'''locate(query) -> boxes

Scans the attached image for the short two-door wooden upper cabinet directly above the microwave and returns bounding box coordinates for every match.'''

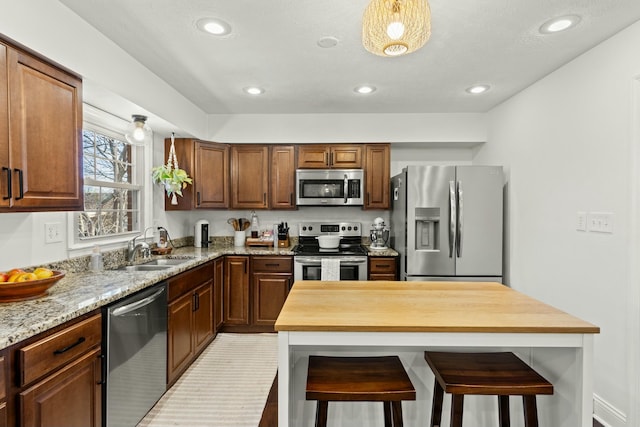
[298,144,363,169]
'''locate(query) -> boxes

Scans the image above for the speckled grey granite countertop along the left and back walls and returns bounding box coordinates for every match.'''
[0,246,398,349]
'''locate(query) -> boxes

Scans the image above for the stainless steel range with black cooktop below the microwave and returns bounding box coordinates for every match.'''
[293,222,367,280]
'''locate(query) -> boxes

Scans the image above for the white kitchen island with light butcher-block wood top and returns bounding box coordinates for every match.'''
[275,281,599,427]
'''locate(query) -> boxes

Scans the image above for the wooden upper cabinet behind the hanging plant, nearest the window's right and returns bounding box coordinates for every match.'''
[164,138,229,210]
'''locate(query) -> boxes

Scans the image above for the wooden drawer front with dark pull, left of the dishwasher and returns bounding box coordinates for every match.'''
[18,314,102,385]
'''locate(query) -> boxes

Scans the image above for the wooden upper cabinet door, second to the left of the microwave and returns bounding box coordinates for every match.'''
[231,145,269,209]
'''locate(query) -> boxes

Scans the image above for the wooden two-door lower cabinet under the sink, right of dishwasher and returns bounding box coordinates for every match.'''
[167,262,214,385]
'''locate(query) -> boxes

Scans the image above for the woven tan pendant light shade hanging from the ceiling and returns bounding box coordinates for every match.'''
[362,0,431,56]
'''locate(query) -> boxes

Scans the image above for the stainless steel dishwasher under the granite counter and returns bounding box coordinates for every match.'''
[103,283,167,427]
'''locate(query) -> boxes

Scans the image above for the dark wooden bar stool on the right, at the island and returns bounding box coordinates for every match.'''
[424,351,553,427]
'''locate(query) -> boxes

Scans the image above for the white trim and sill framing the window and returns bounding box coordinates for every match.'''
[67,103,155,255]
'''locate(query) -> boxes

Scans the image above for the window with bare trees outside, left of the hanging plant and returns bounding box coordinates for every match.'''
[72,104,145,247]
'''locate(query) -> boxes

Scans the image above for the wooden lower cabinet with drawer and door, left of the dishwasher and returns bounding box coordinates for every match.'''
[9,313,102,427]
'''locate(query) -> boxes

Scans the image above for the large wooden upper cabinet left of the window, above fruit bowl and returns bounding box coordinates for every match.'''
[0,40,83,212]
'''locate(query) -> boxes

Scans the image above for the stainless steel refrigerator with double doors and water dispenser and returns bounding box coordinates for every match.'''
[391,166,504,283]
